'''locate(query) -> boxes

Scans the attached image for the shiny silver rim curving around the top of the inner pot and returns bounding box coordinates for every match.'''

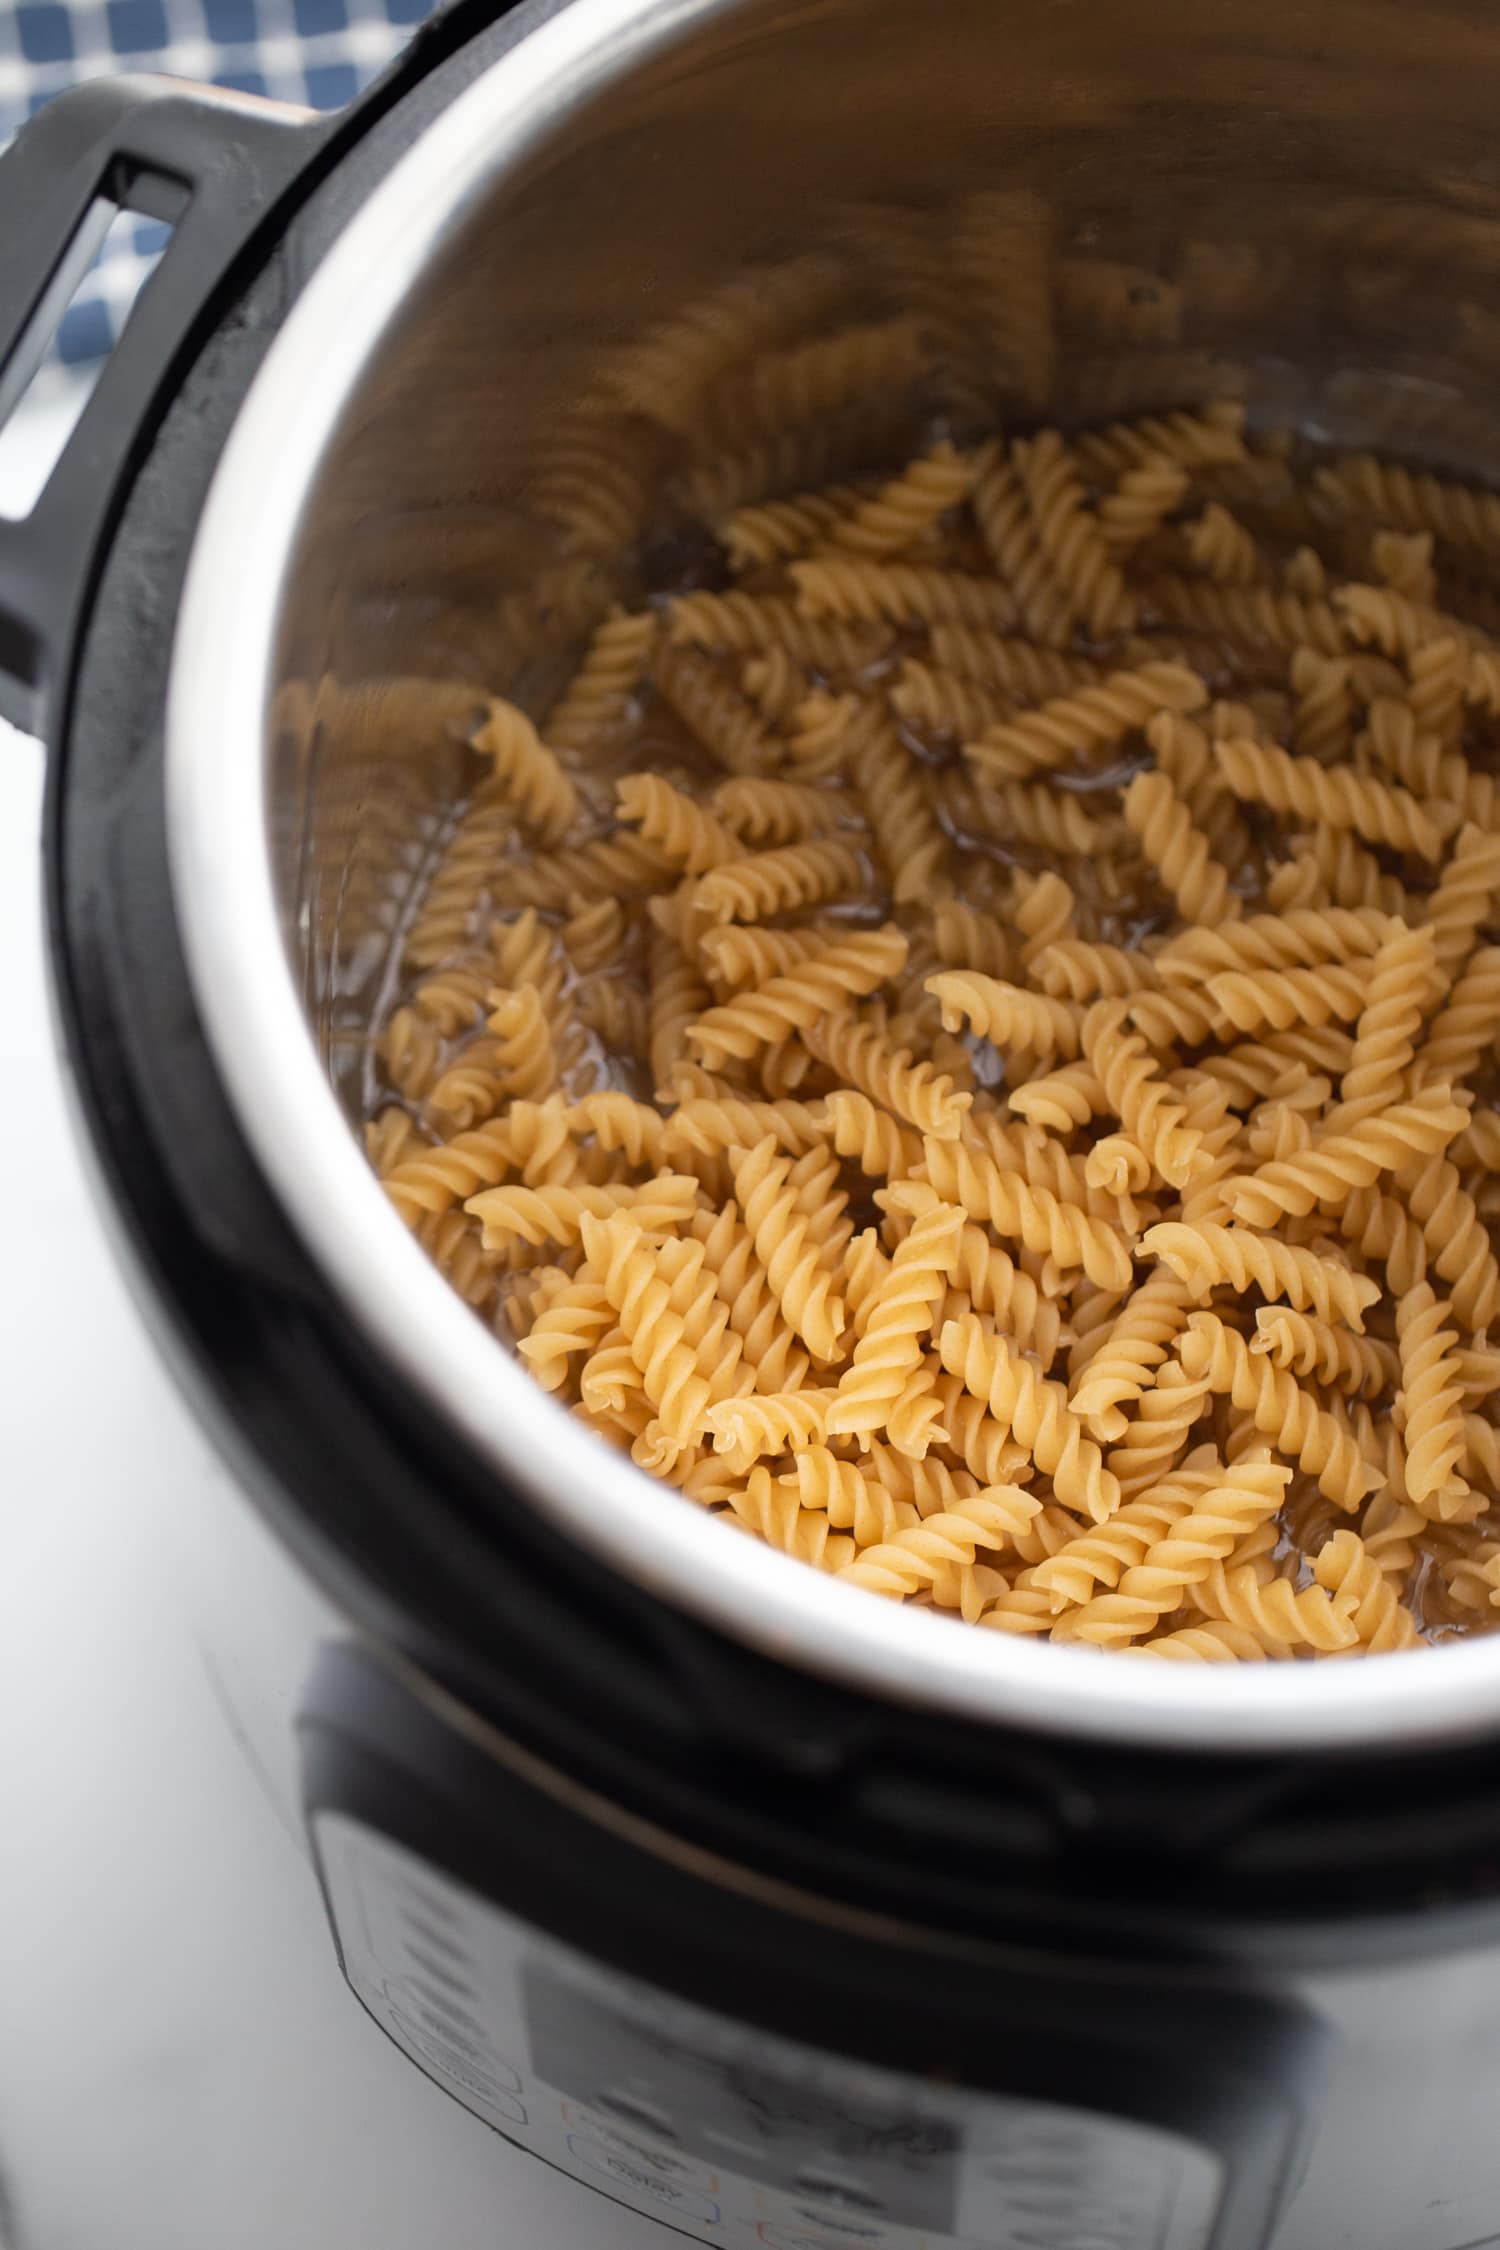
[166,0,1500,1753]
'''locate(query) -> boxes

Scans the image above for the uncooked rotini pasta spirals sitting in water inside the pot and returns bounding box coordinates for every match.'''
[359,391,1500,1663]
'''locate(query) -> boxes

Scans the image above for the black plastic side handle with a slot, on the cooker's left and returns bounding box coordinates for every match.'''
[0,77,328,740]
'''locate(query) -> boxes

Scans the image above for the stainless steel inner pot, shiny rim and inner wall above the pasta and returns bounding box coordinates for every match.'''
[169,0,1500,1748]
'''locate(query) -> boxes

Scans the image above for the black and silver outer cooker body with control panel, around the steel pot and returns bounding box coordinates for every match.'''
[20,0,1500,2250]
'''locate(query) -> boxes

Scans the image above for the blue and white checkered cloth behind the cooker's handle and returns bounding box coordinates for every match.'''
[0,0,434,367]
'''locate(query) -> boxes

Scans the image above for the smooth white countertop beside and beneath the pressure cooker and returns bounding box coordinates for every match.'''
[0,387,659,2250]
